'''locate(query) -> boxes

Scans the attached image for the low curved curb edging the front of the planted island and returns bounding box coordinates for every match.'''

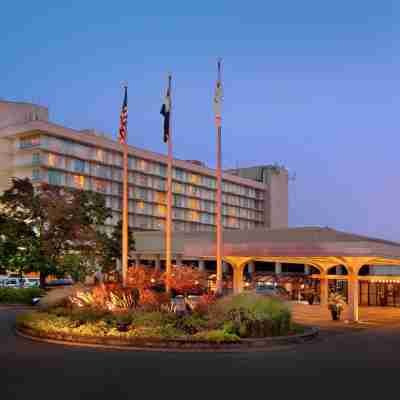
[15,326,319,352]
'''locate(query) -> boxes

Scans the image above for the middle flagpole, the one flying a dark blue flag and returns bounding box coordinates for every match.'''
[165,74,172,293]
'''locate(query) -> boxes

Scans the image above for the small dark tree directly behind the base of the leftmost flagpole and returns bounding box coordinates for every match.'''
[102,220,135,272]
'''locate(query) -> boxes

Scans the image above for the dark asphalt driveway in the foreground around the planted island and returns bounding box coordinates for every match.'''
[0,309,400,400]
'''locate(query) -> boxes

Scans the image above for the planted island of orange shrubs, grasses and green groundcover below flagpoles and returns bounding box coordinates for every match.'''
[17,267,312,345]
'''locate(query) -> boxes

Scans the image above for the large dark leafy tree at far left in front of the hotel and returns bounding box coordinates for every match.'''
[0,178,110,286]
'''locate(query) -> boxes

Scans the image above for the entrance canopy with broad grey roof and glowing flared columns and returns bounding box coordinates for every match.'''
[135,227,400,321]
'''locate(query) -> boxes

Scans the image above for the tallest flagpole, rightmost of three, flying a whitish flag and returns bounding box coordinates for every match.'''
[215,60,222,294]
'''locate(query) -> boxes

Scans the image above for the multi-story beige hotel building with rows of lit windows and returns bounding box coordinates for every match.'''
[0,101,288,232]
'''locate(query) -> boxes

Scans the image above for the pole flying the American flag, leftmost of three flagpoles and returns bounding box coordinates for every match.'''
[122,85,128,287]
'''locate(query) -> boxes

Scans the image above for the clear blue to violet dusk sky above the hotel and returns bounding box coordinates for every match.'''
[0,0,400,241]
